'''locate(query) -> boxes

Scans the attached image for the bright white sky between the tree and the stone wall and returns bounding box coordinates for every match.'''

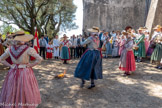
[0,0,83,37]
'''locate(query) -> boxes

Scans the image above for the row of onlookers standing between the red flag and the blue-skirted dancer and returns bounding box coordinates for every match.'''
[39,34,86,64]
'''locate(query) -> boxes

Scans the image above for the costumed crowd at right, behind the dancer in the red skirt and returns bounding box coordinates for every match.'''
[100,25,162,69]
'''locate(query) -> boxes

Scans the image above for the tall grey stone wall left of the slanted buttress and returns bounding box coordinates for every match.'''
[83,0,146,31]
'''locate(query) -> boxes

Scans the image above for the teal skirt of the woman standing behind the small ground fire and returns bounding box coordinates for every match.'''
[60,46,70,60]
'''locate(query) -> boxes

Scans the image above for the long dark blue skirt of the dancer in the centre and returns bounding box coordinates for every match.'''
[74,50,103,80]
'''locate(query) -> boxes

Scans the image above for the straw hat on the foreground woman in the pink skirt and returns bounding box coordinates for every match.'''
[9,31,34,42]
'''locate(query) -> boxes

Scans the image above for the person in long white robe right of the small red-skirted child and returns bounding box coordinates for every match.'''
[53,35,60,59]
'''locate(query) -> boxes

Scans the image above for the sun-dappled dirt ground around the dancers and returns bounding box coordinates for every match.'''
[0,58,162,108]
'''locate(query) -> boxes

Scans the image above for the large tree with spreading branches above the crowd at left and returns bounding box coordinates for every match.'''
[0,0,77,35]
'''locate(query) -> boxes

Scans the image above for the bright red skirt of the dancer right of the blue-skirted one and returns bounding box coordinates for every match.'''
[119,51,136,72]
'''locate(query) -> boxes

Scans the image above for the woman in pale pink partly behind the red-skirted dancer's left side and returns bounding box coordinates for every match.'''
[119,30,128,56]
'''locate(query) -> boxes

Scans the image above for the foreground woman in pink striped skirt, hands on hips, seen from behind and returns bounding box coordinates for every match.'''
[0,31,42,108]
